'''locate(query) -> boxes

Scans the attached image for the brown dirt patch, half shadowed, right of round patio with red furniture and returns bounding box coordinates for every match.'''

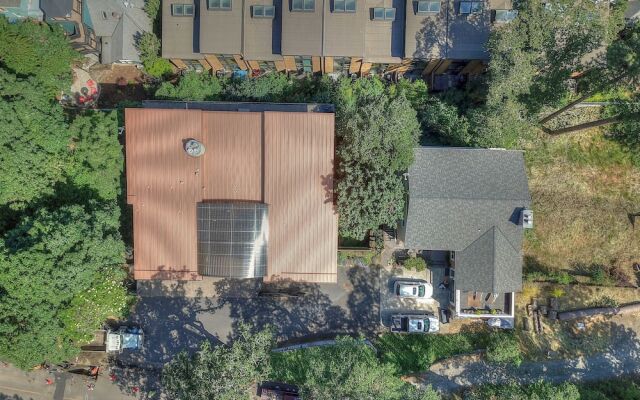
[91,64,148,108]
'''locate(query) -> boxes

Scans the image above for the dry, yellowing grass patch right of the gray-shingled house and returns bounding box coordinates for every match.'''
[524,131,640,283]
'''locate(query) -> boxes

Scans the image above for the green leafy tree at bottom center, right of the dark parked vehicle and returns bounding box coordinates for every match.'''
[272,337,410,400]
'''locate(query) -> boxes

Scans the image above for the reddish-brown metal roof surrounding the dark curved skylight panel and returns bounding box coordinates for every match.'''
[125,108,337,282]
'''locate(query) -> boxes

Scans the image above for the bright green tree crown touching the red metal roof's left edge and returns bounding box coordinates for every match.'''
[66,111,124,200]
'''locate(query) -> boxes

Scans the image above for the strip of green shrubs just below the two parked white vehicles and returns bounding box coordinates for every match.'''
[375,332,488,374]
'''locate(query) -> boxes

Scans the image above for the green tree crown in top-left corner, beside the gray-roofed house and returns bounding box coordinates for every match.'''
[0,17,79,94]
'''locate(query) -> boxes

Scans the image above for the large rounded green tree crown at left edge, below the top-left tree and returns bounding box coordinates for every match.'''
[0,68,70,209]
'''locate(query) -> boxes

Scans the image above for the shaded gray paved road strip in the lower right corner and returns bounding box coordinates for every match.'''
[413,316,640,393]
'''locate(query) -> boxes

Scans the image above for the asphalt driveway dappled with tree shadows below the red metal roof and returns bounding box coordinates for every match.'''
[108,267,380,396]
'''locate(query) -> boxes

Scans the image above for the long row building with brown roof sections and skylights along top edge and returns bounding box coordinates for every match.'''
[162,0,515,75]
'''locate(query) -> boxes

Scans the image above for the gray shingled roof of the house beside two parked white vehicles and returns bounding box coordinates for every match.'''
[404,147,531,292]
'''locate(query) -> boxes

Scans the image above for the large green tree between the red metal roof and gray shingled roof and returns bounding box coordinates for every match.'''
[334,79,420,238]
